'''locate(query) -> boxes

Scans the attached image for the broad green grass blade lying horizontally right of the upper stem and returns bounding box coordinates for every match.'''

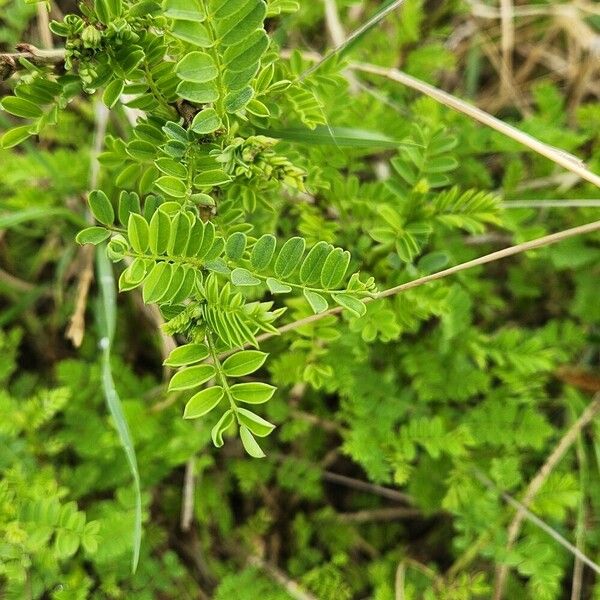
[259,125,416,148]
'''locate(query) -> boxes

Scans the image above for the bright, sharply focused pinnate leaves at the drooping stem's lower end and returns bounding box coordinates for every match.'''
[78,188,374,457]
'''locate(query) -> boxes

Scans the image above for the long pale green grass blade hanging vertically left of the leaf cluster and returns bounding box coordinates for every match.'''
[96,246,142,572]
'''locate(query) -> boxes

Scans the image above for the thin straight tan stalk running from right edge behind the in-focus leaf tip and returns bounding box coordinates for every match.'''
[256,221,600,342]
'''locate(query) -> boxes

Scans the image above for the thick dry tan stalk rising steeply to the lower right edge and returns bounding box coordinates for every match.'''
[493,393,600,600]
